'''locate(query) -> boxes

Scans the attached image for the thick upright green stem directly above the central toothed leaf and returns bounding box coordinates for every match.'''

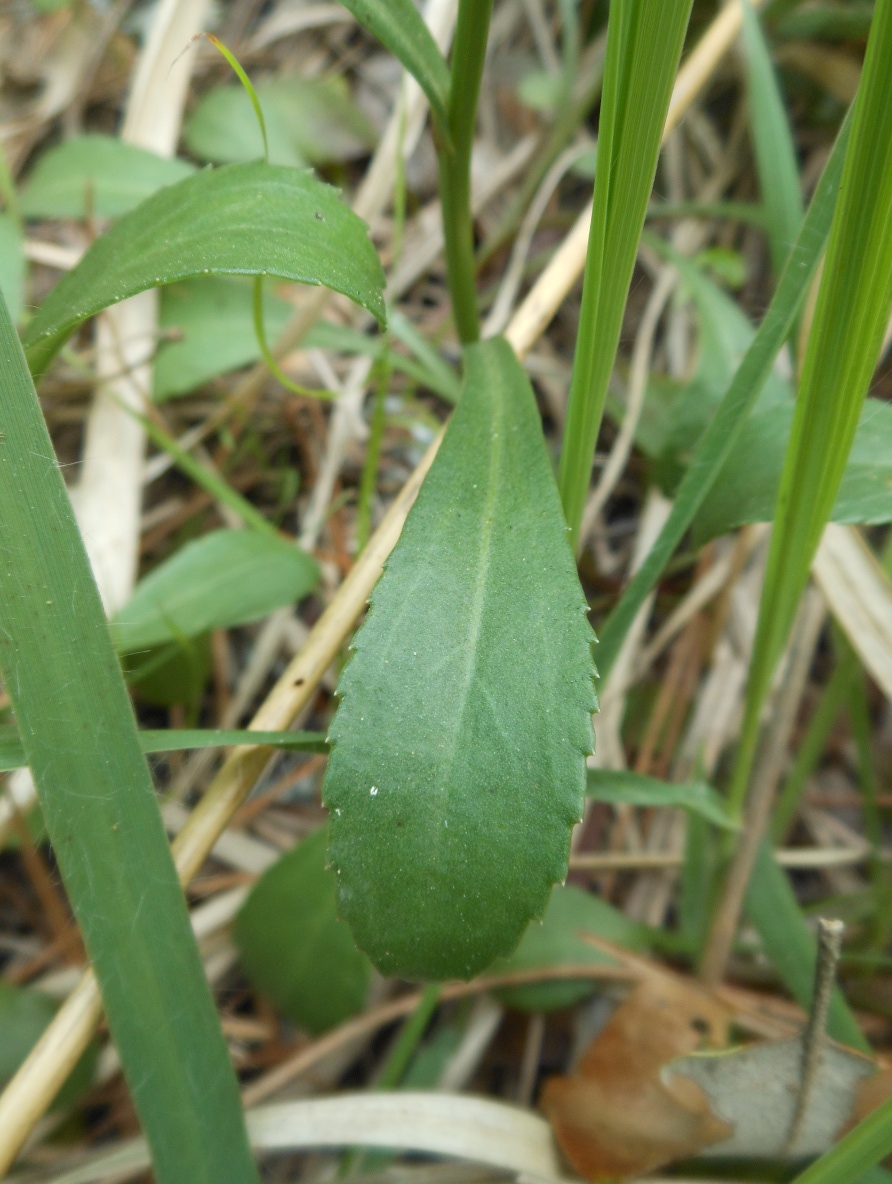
[437,0,493,345]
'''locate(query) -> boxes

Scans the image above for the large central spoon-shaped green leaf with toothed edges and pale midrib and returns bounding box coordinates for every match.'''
[325,339,596,979]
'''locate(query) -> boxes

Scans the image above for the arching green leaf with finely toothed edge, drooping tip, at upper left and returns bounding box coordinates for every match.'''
[25,162,386,373]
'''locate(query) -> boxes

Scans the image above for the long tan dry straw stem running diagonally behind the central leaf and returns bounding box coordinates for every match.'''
[0,0,764,1175]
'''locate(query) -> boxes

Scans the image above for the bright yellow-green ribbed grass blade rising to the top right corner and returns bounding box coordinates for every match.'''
[702,0,892,982]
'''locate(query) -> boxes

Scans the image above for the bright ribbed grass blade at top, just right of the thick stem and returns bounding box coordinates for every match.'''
[558,0,691,546]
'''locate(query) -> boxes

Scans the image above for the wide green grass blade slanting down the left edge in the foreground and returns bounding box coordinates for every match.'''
[0,291,257,1184]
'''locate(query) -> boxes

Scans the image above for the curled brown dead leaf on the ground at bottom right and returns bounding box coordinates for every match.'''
[541,974,732,1180]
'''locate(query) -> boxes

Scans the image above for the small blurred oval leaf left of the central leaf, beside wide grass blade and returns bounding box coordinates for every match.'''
[111,530,319,654]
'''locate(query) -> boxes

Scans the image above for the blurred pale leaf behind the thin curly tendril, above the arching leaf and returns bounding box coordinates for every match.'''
[182,76,376,168]
